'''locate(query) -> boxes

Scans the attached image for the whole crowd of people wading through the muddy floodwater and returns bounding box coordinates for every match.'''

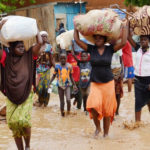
[0,15,150,150]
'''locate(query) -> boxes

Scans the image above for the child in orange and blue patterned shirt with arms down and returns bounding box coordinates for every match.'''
[50,50,77,117]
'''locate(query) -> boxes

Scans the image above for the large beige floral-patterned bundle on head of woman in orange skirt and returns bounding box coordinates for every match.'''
[74,9,122,43]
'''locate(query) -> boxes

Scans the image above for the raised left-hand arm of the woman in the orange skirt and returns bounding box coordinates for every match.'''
[74,29,88,51]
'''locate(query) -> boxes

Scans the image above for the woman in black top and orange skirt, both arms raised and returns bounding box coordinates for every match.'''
[74,19,128,137]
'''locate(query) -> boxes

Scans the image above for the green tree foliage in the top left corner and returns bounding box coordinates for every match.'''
[0,0,36,14]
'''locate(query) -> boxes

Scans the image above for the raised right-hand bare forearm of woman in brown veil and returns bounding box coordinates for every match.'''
[32,32,43,56]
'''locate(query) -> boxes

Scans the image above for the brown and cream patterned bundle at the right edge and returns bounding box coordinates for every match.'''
[129,6,150,35]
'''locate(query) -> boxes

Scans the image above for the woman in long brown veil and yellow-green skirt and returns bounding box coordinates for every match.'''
[0,20,42,150]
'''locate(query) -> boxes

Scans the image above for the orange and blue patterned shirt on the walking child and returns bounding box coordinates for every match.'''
[54,63,72,88]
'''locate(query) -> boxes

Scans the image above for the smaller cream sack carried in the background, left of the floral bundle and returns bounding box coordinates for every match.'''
[56,30,82,50]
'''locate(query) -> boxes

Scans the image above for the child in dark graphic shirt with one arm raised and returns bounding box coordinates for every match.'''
[72,45,92,112]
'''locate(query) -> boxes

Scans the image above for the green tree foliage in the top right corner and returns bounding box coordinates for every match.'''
[125,0,150,7]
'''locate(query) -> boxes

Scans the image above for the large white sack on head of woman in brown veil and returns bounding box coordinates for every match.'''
[0,16,38,42]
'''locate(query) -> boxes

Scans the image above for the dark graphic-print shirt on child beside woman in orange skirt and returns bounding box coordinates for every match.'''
[78,61,92,88]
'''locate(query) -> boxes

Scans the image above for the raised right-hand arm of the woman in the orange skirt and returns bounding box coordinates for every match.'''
[114,20,129,51]
